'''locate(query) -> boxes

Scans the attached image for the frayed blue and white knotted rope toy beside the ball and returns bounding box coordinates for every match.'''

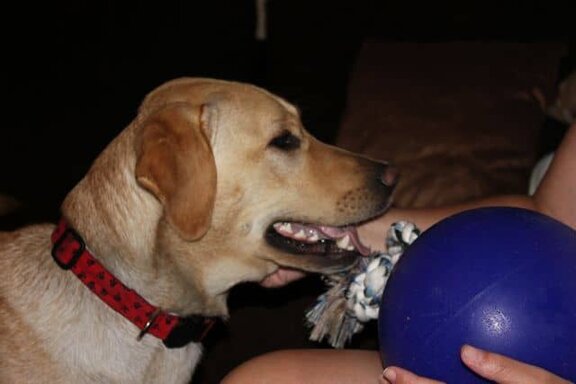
[306,221,420,348]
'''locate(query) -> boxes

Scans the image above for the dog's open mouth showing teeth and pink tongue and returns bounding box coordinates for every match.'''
[265,221,370,259]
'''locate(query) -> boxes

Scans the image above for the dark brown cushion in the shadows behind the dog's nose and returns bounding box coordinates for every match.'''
[336,40,566,207]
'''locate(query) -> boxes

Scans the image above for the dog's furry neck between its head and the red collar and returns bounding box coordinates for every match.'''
[62,127,227,316]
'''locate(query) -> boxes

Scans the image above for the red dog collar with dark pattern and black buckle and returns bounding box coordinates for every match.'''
[52,219,214,348]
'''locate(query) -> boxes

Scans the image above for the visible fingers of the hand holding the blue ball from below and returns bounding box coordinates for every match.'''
[380,345,570,384]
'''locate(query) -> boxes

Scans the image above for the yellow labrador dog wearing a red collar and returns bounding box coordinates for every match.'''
[0,78,395,384]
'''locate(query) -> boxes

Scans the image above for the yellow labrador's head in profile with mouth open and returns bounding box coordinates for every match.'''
[65,79,395,316]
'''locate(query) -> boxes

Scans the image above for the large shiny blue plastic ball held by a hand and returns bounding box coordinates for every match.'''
[378,207,576,383]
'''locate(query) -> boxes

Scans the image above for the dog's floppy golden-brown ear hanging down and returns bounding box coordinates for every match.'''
[136,103,216,240]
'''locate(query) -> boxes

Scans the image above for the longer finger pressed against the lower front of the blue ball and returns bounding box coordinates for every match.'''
[460,345,569,384]
